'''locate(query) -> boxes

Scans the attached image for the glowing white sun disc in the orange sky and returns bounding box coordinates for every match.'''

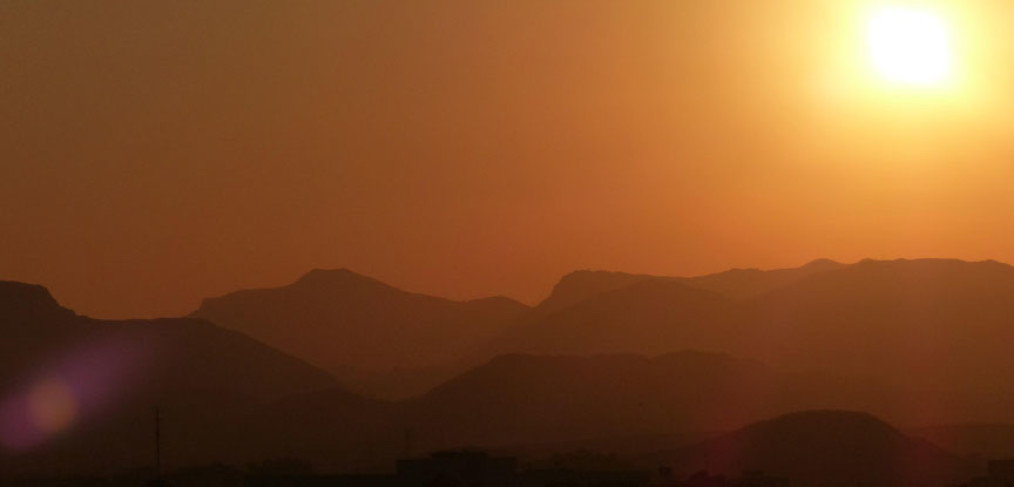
[866,6,953,86]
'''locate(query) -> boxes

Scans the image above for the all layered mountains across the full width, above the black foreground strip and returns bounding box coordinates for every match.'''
[0,256,1014,476]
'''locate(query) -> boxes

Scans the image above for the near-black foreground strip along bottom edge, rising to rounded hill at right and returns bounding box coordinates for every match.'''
[0,411,977,487]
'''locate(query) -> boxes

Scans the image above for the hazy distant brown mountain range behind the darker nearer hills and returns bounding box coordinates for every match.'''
[186,259,1014,422]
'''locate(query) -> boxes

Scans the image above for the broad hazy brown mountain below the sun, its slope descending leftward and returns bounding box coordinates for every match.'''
[491,260,1014,423]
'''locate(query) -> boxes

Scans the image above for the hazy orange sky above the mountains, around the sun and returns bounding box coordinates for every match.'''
[0,0,1014,318]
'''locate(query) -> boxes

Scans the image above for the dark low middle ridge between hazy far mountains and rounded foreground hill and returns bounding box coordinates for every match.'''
[156,351,928,470]
